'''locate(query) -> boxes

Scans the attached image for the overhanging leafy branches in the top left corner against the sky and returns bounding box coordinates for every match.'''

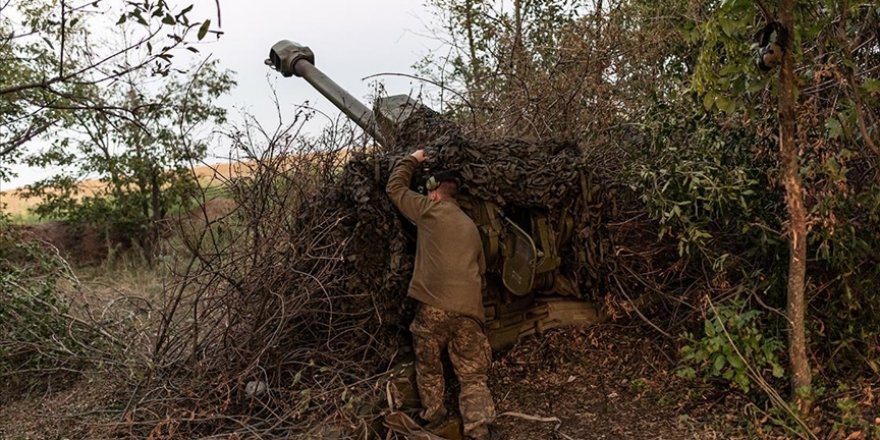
[0,0,219,178]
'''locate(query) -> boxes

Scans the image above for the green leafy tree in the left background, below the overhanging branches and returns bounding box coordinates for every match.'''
[26,61,234,257]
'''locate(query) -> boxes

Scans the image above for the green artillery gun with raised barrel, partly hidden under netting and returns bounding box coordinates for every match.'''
[266,40,605,350]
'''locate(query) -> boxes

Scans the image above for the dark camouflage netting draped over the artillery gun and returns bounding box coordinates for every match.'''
[314,138,607,308]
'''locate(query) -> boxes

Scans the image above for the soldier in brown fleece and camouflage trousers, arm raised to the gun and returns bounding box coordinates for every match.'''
[386,150,495,440]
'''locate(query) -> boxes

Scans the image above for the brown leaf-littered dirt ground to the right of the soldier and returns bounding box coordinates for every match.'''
[490,324,751,440]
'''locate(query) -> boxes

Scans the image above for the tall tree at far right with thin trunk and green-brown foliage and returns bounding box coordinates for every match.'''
[693,0,880,413]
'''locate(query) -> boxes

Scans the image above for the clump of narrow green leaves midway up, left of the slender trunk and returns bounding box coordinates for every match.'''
[628,97,782,262]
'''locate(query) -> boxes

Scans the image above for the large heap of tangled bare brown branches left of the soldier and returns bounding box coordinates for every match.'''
[120,115,411,438]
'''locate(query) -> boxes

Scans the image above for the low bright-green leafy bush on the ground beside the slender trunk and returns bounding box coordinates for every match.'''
[678,303,785,392]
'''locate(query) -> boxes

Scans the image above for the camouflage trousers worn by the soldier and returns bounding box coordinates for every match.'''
[409,304,495,438]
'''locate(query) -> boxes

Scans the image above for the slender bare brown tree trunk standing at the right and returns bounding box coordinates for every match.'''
[779,0,812,415]
